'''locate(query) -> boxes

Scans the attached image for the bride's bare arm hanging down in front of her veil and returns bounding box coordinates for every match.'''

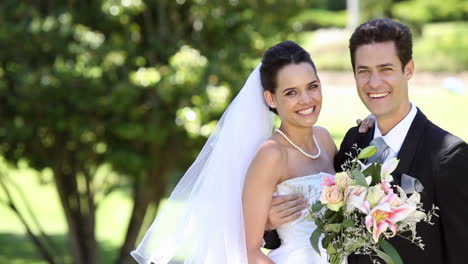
[242,141,287,264]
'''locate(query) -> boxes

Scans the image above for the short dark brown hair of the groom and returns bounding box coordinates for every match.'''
[349,18,413,72]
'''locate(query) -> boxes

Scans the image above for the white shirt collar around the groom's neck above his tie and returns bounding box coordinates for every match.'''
[374,103,417,153]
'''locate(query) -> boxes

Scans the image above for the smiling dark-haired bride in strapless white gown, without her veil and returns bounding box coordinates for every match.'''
[243,41,336,263]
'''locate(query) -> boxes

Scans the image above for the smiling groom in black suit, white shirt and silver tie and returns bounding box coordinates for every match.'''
[265,19,468,264]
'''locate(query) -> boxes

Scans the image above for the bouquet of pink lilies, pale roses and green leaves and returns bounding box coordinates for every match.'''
[310,146,437,264]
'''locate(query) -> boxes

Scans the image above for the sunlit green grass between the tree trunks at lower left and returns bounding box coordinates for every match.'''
[0,166,131,264]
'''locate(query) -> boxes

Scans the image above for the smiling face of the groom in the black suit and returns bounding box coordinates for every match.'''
[354,41,414,120]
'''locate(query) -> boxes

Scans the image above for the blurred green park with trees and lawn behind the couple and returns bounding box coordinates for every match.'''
[0,0,468,264]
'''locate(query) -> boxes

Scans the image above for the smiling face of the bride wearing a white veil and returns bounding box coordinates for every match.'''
[265,62,322,128]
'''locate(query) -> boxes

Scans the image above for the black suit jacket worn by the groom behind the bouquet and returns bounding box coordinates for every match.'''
[265,109,468,264]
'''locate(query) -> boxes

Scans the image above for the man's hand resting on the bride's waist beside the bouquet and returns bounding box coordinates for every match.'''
[265,194,309,231]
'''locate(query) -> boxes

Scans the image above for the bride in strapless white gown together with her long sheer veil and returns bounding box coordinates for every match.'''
[131,41,368,264]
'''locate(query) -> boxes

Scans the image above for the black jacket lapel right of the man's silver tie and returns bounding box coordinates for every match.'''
[392,109,428,185]
